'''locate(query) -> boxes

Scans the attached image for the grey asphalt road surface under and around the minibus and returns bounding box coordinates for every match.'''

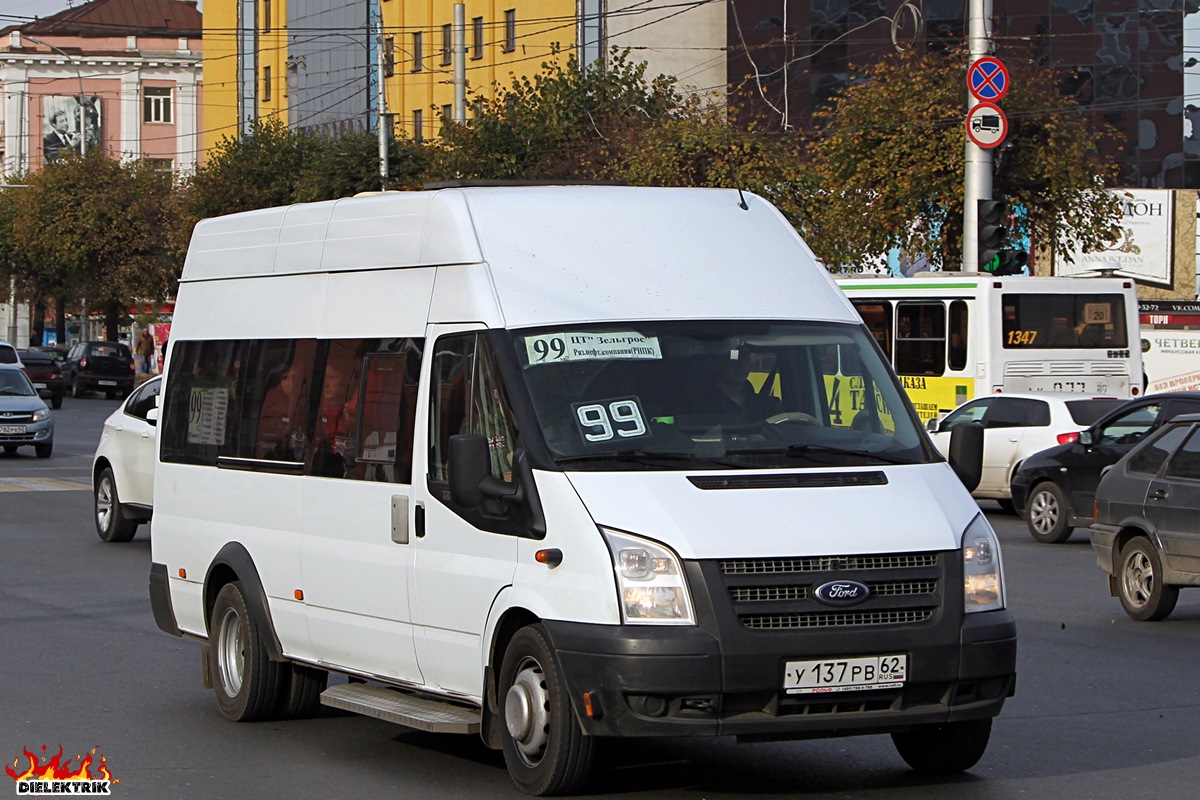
[0,398,1200,800]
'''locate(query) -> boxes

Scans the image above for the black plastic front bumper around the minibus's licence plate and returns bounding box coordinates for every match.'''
[545,556,1016,739]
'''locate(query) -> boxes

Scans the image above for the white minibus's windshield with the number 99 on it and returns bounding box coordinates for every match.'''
[512,320,938,470]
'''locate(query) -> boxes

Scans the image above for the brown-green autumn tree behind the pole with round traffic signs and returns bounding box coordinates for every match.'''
[803,52,1120,269]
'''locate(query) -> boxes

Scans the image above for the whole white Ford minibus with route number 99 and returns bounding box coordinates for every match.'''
[150,186,1016,795]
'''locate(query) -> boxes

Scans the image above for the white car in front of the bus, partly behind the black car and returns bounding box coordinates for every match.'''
[929,392,1121,511]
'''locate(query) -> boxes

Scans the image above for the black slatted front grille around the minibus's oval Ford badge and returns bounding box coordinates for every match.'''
[716,552,948,631]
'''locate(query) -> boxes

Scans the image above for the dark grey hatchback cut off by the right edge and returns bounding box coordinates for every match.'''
[1091,414,1200,620]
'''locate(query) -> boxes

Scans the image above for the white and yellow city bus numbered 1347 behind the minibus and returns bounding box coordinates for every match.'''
[838,272,1145,422]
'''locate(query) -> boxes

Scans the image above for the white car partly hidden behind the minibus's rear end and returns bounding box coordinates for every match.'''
[91,378,162,542]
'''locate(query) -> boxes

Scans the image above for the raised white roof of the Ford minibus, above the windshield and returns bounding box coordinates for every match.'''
[181,186,858,326]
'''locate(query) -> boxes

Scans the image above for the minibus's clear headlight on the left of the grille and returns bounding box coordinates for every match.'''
[600,528,696,625]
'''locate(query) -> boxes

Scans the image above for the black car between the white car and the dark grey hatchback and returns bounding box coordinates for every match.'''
[1012,392,1200,543]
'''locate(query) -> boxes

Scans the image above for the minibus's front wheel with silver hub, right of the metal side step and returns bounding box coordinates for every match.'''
[499,625,595,796]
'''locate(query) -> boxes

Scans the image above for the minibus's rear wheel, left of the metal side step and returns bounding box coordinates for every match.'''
[209,581,287,722]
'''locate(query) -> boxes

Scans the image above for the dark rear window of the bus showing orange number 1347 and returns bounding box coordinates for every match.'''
[1001,293,1129,350]
